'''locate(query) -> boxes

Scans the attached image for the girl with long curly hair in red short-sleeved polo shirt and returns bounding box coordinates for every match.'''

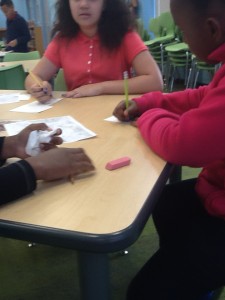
[25,0,163,102]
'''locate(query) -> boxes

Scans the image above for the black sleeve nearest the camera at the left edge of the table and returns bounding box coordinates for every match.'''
[0,160,36,204]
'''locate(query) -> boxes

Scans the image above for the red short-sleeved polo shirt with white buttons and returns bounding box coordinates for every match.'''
[44,31,147,90]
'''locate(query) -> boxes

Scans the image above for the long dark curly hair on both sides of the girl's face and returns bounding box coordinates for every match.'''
[52,0,135,50]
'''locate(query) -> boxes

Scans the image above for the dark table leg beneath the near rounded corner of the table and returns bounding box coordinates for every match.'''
[78,252,110,300]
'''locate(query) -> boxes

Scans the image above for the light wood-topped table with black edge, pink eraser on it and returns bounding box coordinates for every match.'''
[0,91,171,300]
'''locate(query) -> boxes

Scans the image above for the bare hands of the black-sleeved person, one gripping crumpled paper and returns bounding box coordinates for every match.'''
[1,123,95,180]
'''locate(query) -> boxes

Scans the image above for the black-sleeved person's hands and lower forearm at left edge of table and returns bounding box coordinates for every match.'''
[0,123,94,204]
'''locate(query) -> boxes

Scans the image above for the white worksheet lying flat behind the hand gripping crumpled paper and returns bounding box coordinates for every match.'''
[4,116,96,143]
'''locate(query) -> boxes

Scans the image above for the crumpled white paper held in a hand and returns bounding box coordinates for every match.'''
[25,129,57,156]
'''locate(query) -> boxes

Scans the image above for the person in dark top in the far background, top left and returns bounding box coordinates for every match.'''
[0,0,31,52]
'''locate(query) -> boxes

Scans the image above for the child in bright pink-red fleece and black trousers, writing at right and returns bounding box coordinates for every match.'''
[114,0,225,300]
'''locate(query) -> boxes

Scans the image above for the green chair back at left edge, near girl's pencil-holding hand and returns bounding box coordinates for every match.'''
[0,64,26,90]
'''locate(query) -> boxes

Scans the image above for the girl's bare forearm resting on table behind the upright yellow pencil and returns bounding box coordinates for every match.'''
[99,75,163,94]
